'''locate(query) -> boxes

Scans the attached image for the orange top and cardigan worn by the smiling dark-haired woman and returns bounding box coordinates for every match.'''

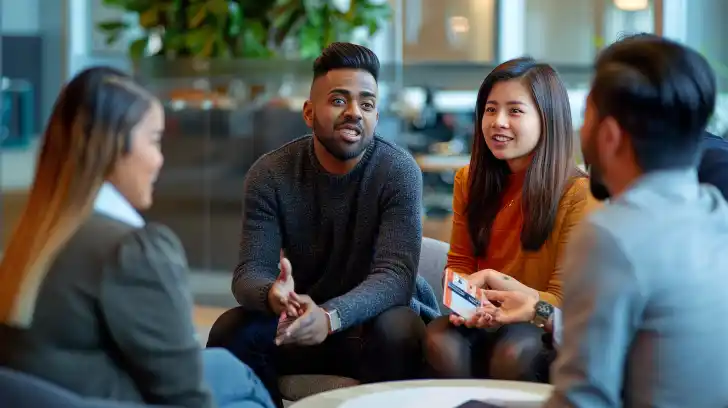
[447,167,599,306]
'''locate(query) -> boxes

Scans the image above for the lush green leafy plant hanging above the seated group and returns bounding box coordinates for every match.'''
[98,0,391,59]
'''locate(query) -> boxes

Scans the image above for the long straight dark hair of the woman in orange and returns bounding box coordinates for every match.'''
[467,58,583,257]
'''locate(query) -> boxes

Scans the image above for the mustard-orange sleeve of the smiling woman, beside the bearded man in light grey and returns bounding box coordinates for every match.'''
[538,178,599,306]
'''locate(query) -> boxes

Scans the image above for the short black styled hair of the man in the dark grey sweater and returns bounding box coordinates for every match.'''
[313,42,379,81]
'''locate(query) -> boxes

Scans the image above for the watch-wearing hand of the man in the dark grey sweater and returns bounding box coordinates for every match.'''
[276,294,329,346]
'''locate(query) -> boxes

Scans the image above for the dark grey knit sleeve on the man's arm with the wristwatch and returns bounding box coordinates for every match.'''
[322,157,422,329]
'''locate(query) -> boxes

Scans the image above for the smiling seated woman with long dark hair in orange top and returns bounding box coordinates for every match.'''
[425,58,596,381]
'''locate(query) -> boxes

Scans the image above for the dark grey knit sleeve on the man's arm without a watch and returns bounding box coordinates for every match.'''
[232,160,282,312]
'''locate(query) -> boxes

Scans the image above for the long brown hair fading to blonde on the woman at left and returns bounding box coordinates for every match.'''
[0,67,152,327]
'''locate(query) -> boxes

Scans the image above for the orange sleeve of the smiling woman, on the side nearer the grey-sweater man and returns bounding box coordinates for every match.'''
[447,167,478,275]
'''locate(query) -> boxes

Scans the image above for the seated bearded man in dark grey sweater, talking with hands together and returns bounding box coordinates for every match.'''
[210,43,424,403]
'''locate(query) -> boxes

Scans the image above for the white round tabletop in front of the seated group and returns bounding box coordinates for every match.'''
[291,380,551,408]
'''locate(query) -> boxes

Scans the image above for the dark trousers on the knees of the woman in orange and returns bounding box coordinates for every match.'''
[425,316,553,382]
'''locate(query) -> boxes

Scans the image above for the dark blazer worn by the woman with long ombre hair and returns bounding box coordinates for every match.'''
[0,214,213,408]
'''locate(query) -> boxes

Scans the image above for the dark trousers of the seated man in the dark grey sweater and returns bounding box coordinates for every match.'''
[208,306,425,406]
